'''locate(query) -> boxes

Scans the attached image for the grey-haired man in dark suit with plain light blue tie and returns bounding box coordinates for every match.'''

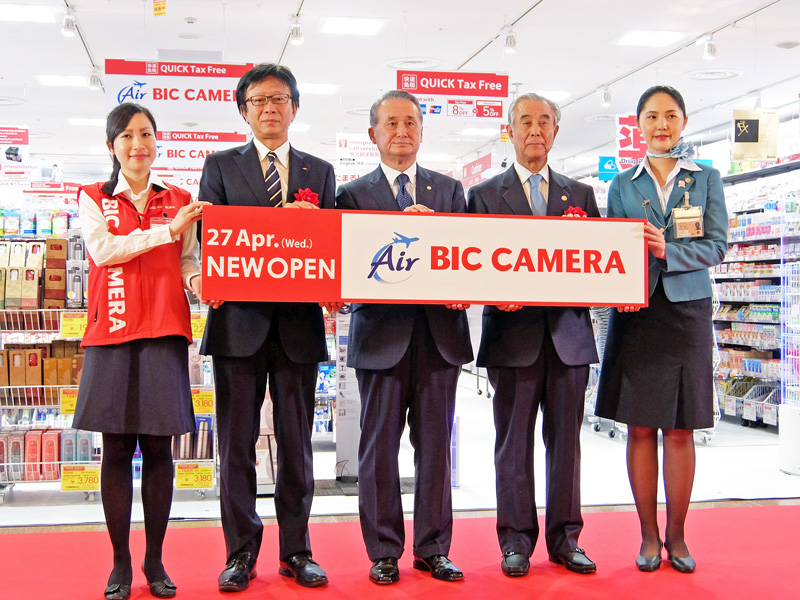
[467,94,600,577]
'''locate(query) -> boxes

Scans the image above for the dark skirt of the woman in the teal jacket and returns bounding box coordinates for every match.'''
[595,281,714,429]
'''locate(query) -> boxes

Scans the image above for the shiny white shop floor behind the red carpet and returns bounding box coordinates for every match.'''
[0,373,800,527]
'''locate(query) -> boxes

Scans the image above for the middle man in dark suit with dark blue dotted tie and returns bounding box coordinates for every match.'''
[336,90,472,584]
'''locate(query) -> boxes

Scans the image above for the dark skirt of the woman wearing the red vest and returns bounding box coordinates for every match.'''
[72,335,195,436]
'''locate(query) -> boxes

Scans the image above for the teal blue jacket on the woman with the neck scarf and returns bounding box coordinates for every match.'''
[608,164,728,302]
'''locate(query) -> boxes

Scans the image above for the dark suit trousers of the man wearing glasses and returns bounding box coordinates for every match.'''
[214,326,317,560]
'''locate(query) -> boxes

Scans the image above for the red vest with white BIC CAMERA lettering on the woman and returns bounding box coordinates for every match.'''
[81,183,192,346]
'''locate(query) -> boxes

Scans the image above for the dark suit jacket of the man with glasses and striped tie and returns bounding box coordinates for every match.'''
[199,142,335,363]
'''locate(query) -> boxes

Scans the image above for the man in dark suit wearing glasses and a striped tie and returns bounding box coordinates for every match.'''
[199,64,338,591]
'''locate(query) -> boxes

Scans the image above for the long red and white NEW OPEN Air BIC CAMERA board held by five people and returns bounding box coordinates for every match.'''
[202,206,647,306]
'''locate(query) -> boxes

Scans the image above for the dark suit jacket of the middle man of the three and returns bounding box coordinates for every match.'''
[336,165,472,369]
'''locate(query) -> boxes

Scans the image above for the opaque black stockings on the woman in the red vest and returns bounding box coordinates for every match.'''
[100,433,173,585]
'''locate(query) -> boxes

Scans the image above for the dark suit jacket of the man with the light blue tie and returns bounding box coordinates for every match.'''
[467,165,600,367]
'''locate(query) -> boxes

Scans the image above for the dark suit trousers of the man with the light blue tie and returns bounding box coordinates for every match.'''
[488,331,589,556]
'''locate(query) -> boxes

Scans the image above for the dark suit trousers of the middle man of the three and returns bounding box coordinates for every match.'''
[356,309,461,561]
